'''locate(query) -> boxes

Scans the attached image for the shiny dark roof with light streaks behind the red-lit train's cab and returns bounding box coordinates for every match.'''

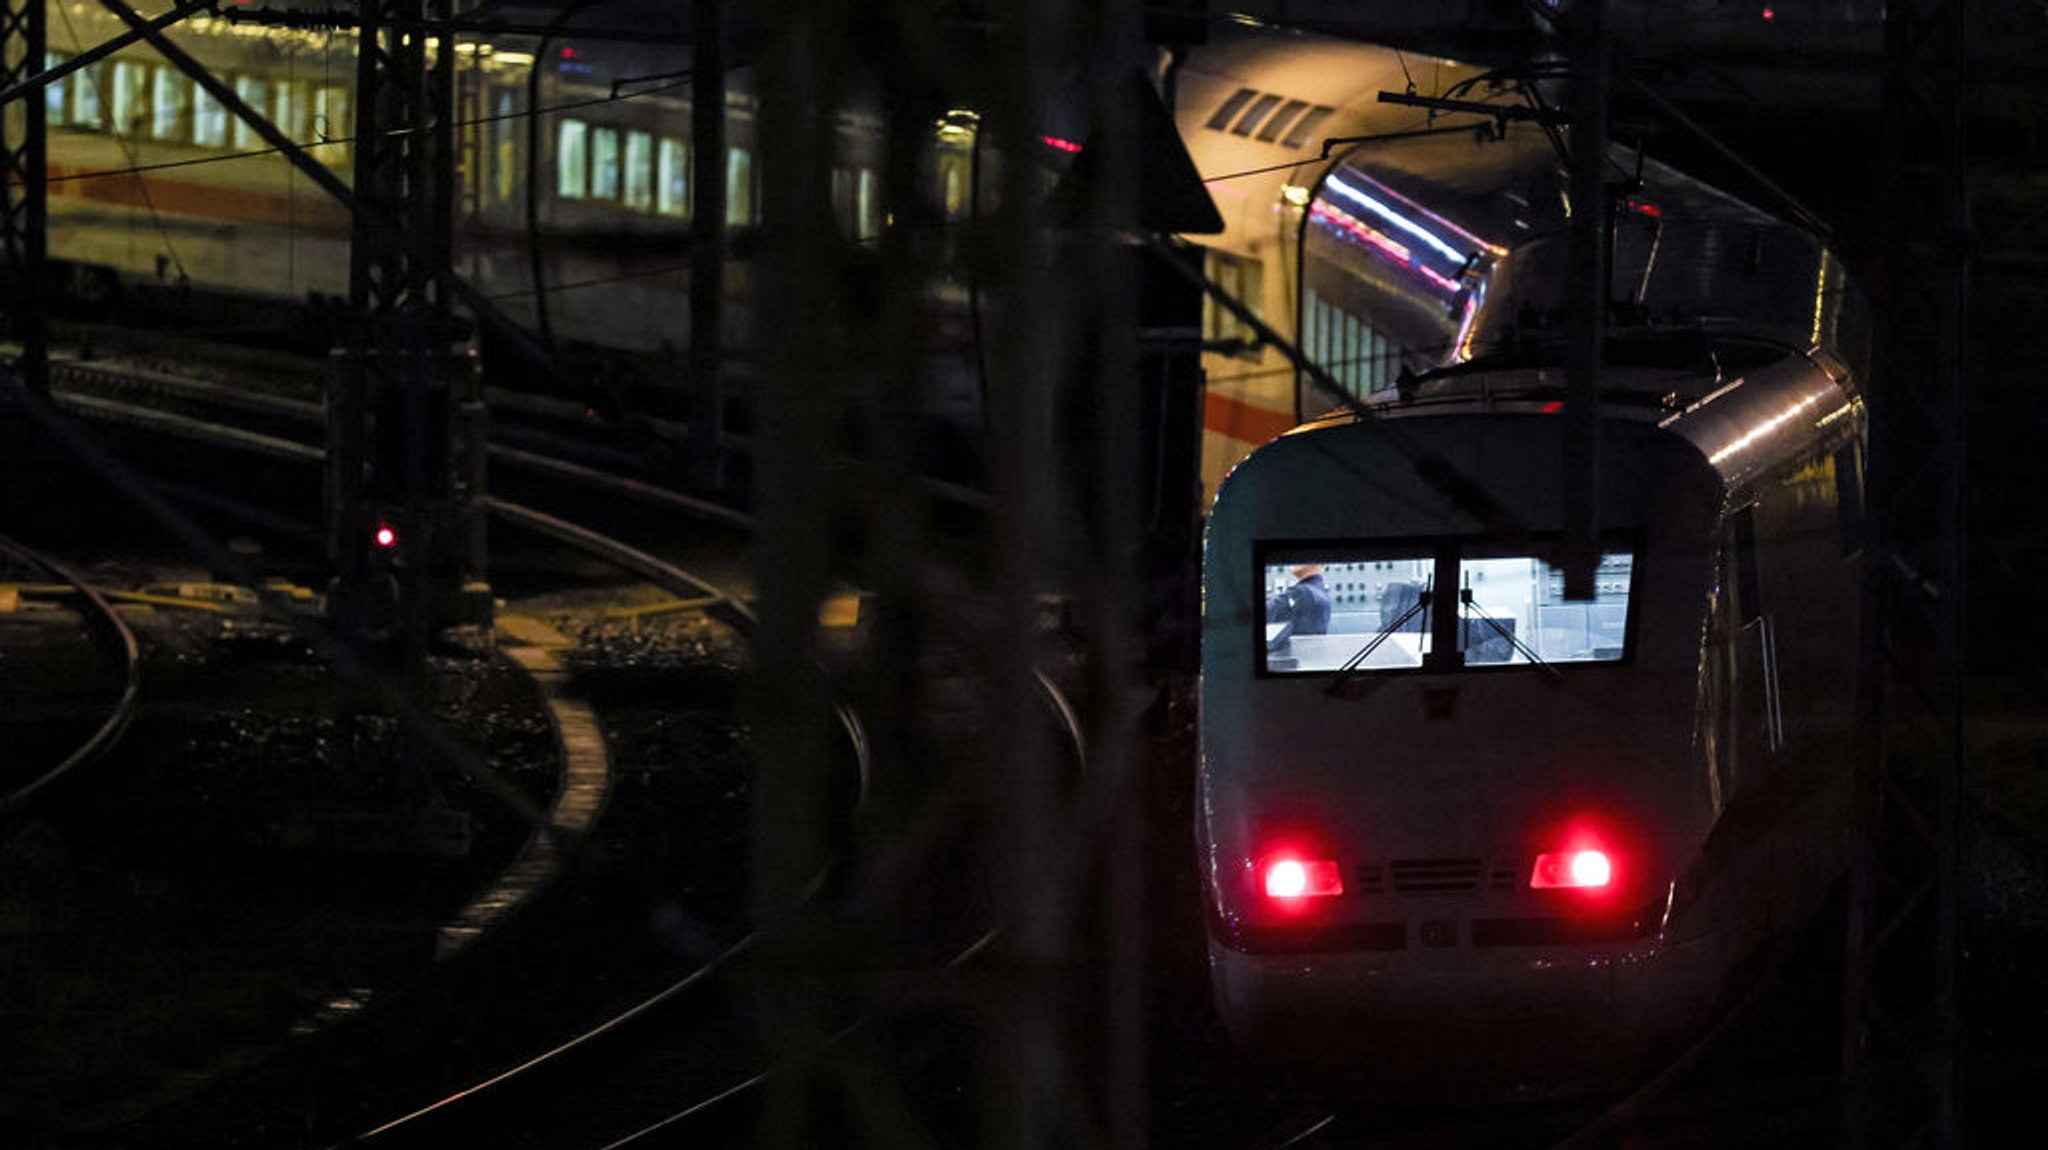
[1303,121,1868,387]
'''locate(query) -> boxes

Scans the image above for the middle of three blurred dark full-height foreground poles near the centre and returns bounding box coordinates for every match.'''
[981,0,1081,1150]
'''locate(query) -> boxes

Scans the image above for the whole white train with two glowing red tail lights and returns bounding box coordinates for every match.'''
[1182,24,1870,1105]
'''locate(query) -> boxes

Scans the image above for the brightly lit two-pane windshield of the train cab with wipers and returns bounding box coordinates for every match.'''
[1260,540,1634,675]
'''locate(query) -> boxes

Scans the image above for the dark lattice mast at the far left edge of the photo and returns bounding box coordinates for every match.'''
[0,0,49,395]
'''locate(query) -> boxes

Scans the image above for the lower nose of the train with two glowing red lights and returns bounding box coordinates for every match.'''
[1210,776,1718,1101]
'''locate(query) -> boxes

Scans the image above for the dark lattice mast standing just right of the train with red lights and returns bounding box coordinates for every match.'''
[1843,0,1972,1150]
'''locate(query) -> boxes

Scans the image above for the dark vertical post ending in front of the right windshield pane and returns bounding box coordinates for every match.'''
[1563,0,1608,600]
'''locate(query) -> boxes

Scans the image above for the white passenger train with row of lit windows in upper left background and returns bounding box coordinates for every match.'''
[28,2,950,341]
